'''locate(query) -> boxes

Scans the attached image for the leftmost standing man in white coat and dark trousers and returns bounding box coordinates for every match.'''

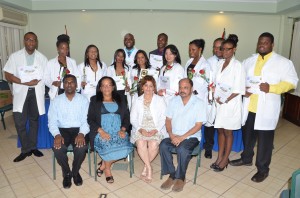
[3,32,48,162]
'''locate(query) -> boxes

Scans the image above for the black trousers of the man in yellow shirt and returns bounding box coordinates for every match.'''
[241,112,275,173]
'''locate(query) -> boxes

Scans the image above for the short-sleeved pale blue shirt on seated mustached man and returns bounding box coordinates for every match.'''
[166,95,206,141]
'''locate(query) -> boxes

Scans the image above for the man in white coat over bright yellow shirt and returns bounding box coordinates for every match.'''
[230,32,298,182]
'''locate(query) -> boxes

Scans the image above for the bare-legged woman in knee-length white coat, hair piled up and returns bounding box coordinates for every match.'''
[211,35,245,172]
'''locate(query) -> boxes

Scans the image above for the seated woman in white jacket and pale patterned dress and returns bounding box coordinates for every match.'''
[130,76,167,183]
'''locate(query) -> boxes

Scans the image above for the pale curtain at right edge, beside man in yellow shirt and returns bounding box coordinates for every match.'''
[291,20,300,96]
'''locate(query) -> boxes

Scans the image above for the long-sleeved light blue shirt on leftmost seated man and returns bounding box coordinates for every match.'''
[48,93,90,137]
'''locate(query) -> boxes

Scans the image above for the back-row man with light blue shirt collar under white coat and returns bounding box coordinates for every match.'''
[124,33,138,68]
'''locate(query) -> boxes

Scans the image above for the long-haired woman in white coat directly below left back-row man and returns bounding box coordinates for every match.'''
[106,49,130,104]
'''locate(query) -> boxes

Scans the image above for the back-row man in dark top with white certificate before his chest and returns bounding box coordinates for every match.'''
[149,33,168,70]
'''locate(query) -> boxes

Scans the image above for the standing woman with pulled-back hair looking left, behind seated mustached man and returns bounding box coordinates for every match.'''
[184,39,212,104]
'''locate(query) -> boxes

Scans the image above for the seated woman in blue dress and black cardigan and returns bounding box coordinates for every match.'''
[88,76,133,183]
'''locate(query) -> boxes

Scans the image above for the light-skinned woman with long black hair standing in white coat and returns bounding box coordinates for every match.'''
[157,45,184,104]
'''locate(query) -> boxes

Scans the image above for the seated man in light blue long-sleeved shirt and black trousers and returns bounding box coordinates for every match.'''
[48,74,89,188]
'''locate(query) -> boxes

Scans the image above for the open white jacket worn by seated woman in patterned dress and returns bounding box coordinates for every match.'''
[130,94,168,143]
